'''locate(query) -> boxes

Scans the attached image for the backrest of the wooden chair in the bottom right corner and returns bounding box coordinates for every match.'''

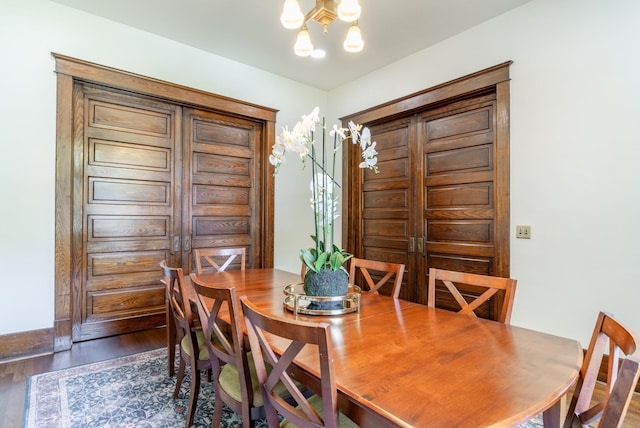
[564,312,640,428]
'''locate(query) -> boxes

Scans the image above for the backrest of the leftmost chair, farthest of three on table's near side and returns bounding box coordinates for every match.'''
[160,260,197,343]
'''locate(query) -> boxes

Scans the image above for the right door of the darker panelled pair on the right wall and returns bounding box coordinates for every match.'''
[418,94,502,317]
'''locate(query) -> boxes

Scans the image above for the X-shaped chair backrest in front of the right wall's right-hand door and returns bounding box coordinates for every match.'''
[427,268,517,324]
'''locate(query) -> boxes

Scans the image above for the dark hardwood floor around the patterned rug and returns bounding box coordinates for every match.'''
[0,328,640,428]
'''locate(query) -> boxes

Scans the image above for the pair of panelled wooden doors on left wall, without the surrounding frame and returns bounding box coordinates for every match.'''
[72,82,264,341]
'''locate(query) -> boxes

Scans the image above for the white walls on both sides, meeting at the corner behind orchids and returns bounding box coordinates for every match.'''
[0,0,640,346]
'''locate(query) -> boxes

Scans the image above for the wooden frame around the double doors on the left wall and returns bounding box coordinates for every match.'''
[52,53,278,352]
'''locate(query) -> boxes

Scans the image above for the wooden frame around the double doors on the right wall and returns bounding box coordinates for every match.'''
[340,61,513,277]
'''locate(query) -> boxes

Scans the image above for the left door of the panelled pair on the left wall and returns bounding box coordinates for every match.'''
[73,84,181,341]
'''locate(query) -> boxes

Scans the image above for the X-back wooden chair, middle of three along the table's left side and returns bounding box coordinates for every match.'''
[190,273,272,427]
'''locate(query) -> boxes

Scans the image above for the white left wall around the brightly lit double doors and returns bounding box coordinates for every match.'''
[0,0,327,335]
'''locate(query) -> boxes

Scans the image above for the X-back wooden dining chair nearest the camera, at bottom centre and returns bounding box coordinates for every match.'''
[240,296,357,428]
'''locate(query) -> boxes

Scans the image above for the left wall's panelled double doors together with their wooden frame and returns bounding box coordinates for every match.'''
[53,54,276,351]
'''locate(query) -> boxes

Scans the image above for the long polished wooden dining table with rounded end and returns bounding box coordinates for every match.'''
[192,268,583,428]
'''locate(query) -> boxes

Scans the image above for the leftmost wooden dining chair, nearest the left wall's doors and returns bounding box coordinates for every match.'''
[160,260,211,427]
